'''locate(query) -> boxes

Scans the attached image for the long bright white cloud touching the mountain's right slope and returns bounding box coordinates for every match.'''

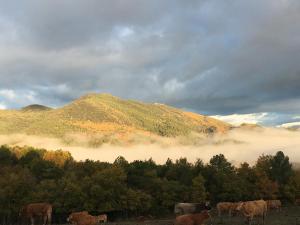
[212,112,269,126]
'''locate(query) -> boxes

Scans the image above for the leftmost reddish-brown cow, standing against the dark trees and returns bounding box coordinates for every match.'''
[19,203,52,225]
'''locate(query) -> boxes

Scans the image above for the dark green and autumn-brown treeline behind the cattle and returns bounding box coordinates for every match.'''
[0,146,300,222]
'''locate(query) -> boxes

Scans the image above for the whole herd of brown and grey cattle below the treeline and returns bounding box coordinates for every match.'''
[19,199,300,225]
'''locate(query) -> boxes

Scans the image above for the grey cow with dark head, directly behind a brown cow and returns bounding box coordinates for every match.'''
[174,202,211,215]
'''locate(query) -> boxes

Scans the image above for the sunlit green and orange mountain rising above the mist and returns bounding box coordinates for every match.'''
[0,94,231,143]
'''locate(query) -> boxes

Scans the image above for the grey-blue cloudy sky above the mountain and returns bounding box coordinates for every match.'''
[0,0,300,124]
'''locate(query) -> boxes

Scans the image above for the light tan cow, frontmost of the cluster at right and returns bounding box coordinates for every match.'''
[236,200,267,224]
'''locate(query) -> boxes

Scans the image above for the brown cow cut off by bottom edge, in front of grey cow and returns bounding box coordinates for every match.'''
[175,210,210,225]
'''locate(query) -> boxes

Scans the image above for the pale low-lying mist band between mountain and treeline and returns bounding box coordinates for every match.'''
[0,128,300,164]
